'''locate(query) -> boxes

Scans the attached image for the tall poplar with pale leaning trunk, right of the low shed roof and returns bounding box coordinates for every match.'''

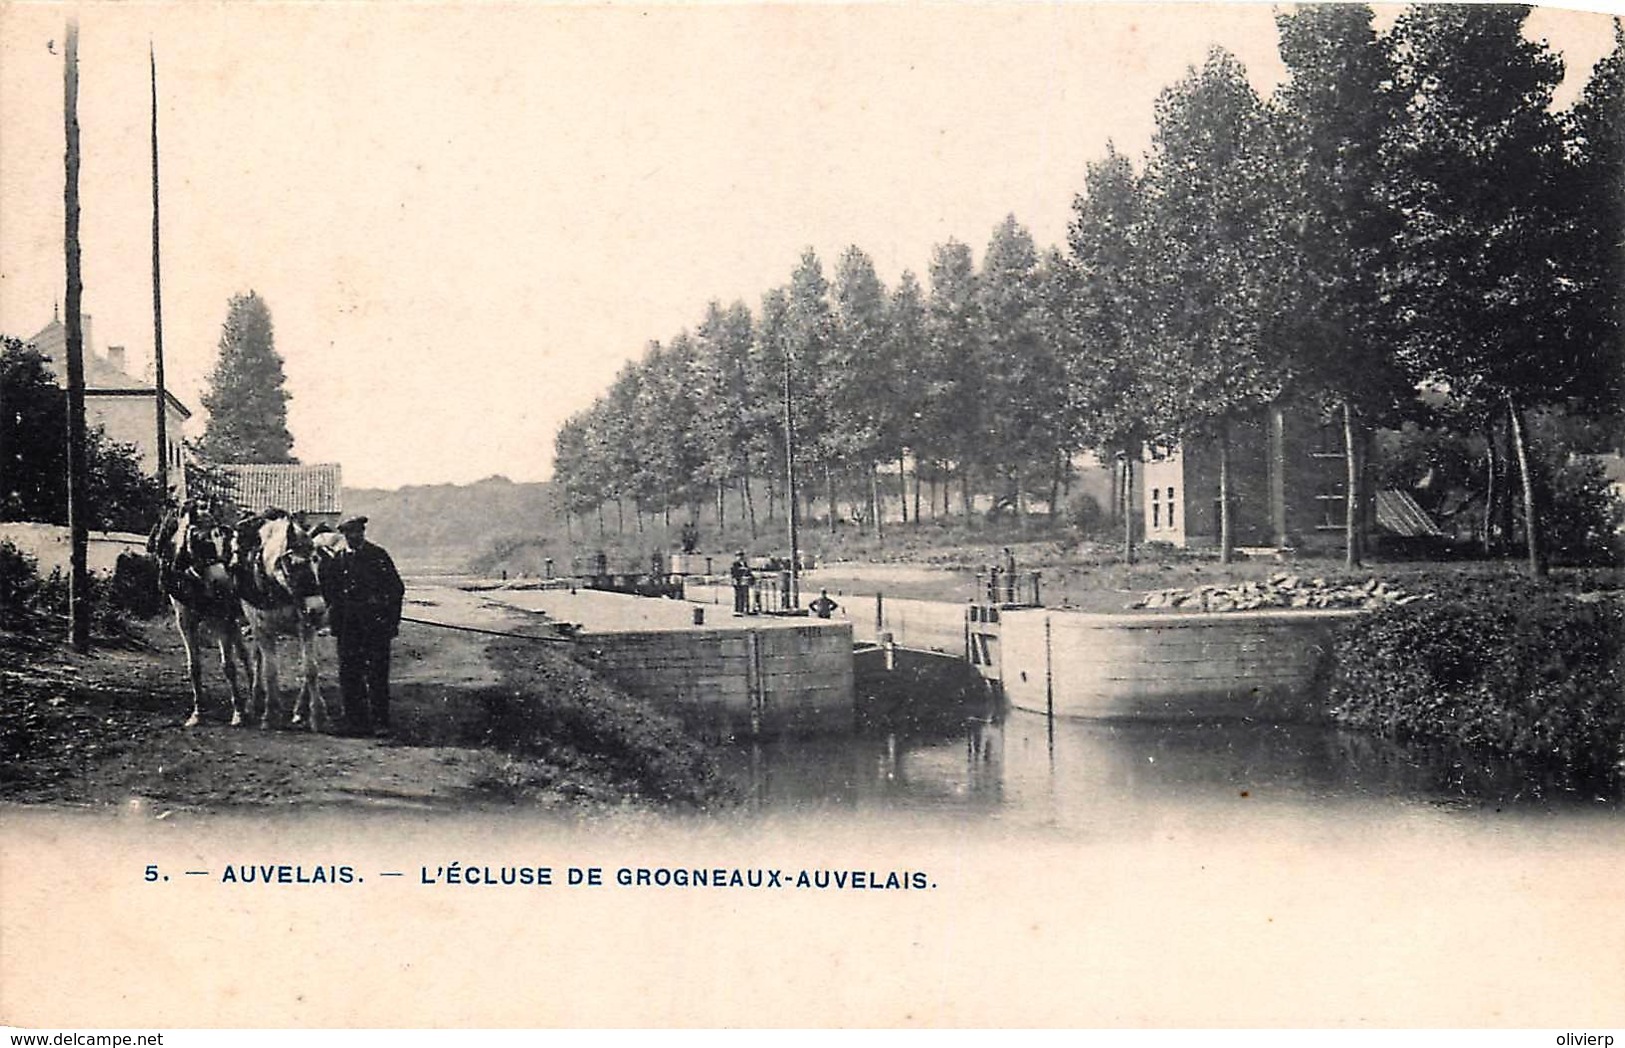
[1389,5,1617,575]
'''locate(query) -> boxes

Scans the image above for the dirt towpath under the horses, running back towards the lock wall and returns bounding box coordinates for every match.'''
[0,587,724,817]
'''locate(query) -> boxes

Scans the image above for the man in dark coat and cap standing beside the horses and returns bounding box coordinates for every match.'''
[323,517,406,734]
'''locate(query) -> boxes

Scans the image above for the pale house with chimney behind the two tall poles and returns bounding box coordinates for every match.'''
[28,314,192,492]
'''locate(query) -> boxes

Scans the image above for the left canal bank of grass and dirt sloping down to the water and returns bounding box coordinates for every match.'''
[0,607,730,817]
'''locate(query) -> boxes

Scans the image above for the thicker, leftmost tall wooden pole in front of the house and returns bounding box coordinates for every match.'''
[62,19,91,653]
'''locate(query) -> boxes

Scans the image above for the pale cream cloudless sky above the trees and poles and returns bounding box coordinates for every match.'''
[0,0,1620,487]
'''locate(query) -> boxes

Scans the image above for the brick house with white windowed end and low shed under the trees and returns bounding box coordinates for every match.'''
[1141,405,1443,549]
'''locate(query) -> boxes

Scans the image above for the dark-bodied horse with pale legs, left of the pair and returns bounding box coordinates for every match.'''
[146,500,249,728]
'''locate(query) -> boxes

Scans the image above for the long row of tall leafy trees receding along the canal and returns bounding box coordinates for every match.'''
[556,5,1625,570]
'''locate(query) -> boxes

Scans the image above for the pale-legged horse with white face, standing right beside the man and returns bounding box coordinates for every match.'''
[234,509,335,731]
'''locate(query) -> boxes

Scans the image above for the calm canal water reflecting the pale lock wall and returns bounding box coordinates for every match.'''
[728,710,1620,827]
